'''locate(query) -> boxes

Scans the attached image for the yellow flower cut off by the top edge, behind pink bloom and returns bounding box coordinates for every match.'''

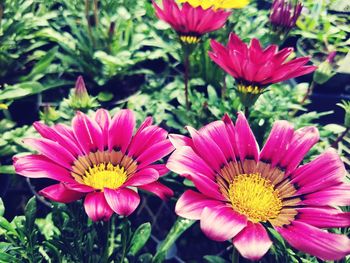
[179,0,249,9]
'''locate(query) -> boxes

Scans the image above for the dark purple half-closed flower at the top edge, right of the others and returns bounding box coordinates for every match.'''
[270,0,303,32]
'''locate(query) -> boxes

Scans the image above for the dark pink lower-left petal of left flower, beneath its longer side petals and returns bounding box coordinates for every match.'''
[39,183,84,203]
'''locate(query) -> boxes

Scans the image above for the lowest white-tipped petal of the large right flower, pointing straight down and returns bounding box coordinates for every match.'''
[233,222,272,261]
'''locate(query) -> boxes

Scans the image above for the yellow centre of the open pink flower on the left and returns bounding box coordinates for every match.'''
[82,163,127,190]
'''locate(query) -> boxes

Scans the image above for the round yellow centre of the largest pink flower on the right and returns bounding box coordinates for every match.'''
[229,173,282,223]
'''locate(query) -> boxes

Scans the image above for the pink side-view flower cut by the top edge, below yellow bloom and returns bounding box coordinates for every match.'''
[153,0,231,44]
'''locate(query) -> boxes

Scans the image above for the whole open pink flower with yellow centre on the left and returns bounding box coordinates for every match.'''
[14,109,173,221]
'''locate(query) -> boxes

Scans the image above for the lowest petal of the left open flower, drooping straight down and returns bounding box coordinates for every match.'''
[84,192,113,222]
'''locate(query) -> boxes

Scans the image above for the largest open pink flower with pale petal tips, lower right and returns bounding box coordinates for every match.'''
[167,113,350,260]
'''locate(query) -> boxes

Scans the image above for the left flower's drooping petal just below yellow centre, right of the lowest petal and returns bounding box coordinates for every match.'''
[104,188,140,216]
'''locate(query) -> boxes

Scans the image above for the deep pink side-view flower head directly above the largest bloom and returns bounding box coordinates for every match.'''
[209,33,316,106]
